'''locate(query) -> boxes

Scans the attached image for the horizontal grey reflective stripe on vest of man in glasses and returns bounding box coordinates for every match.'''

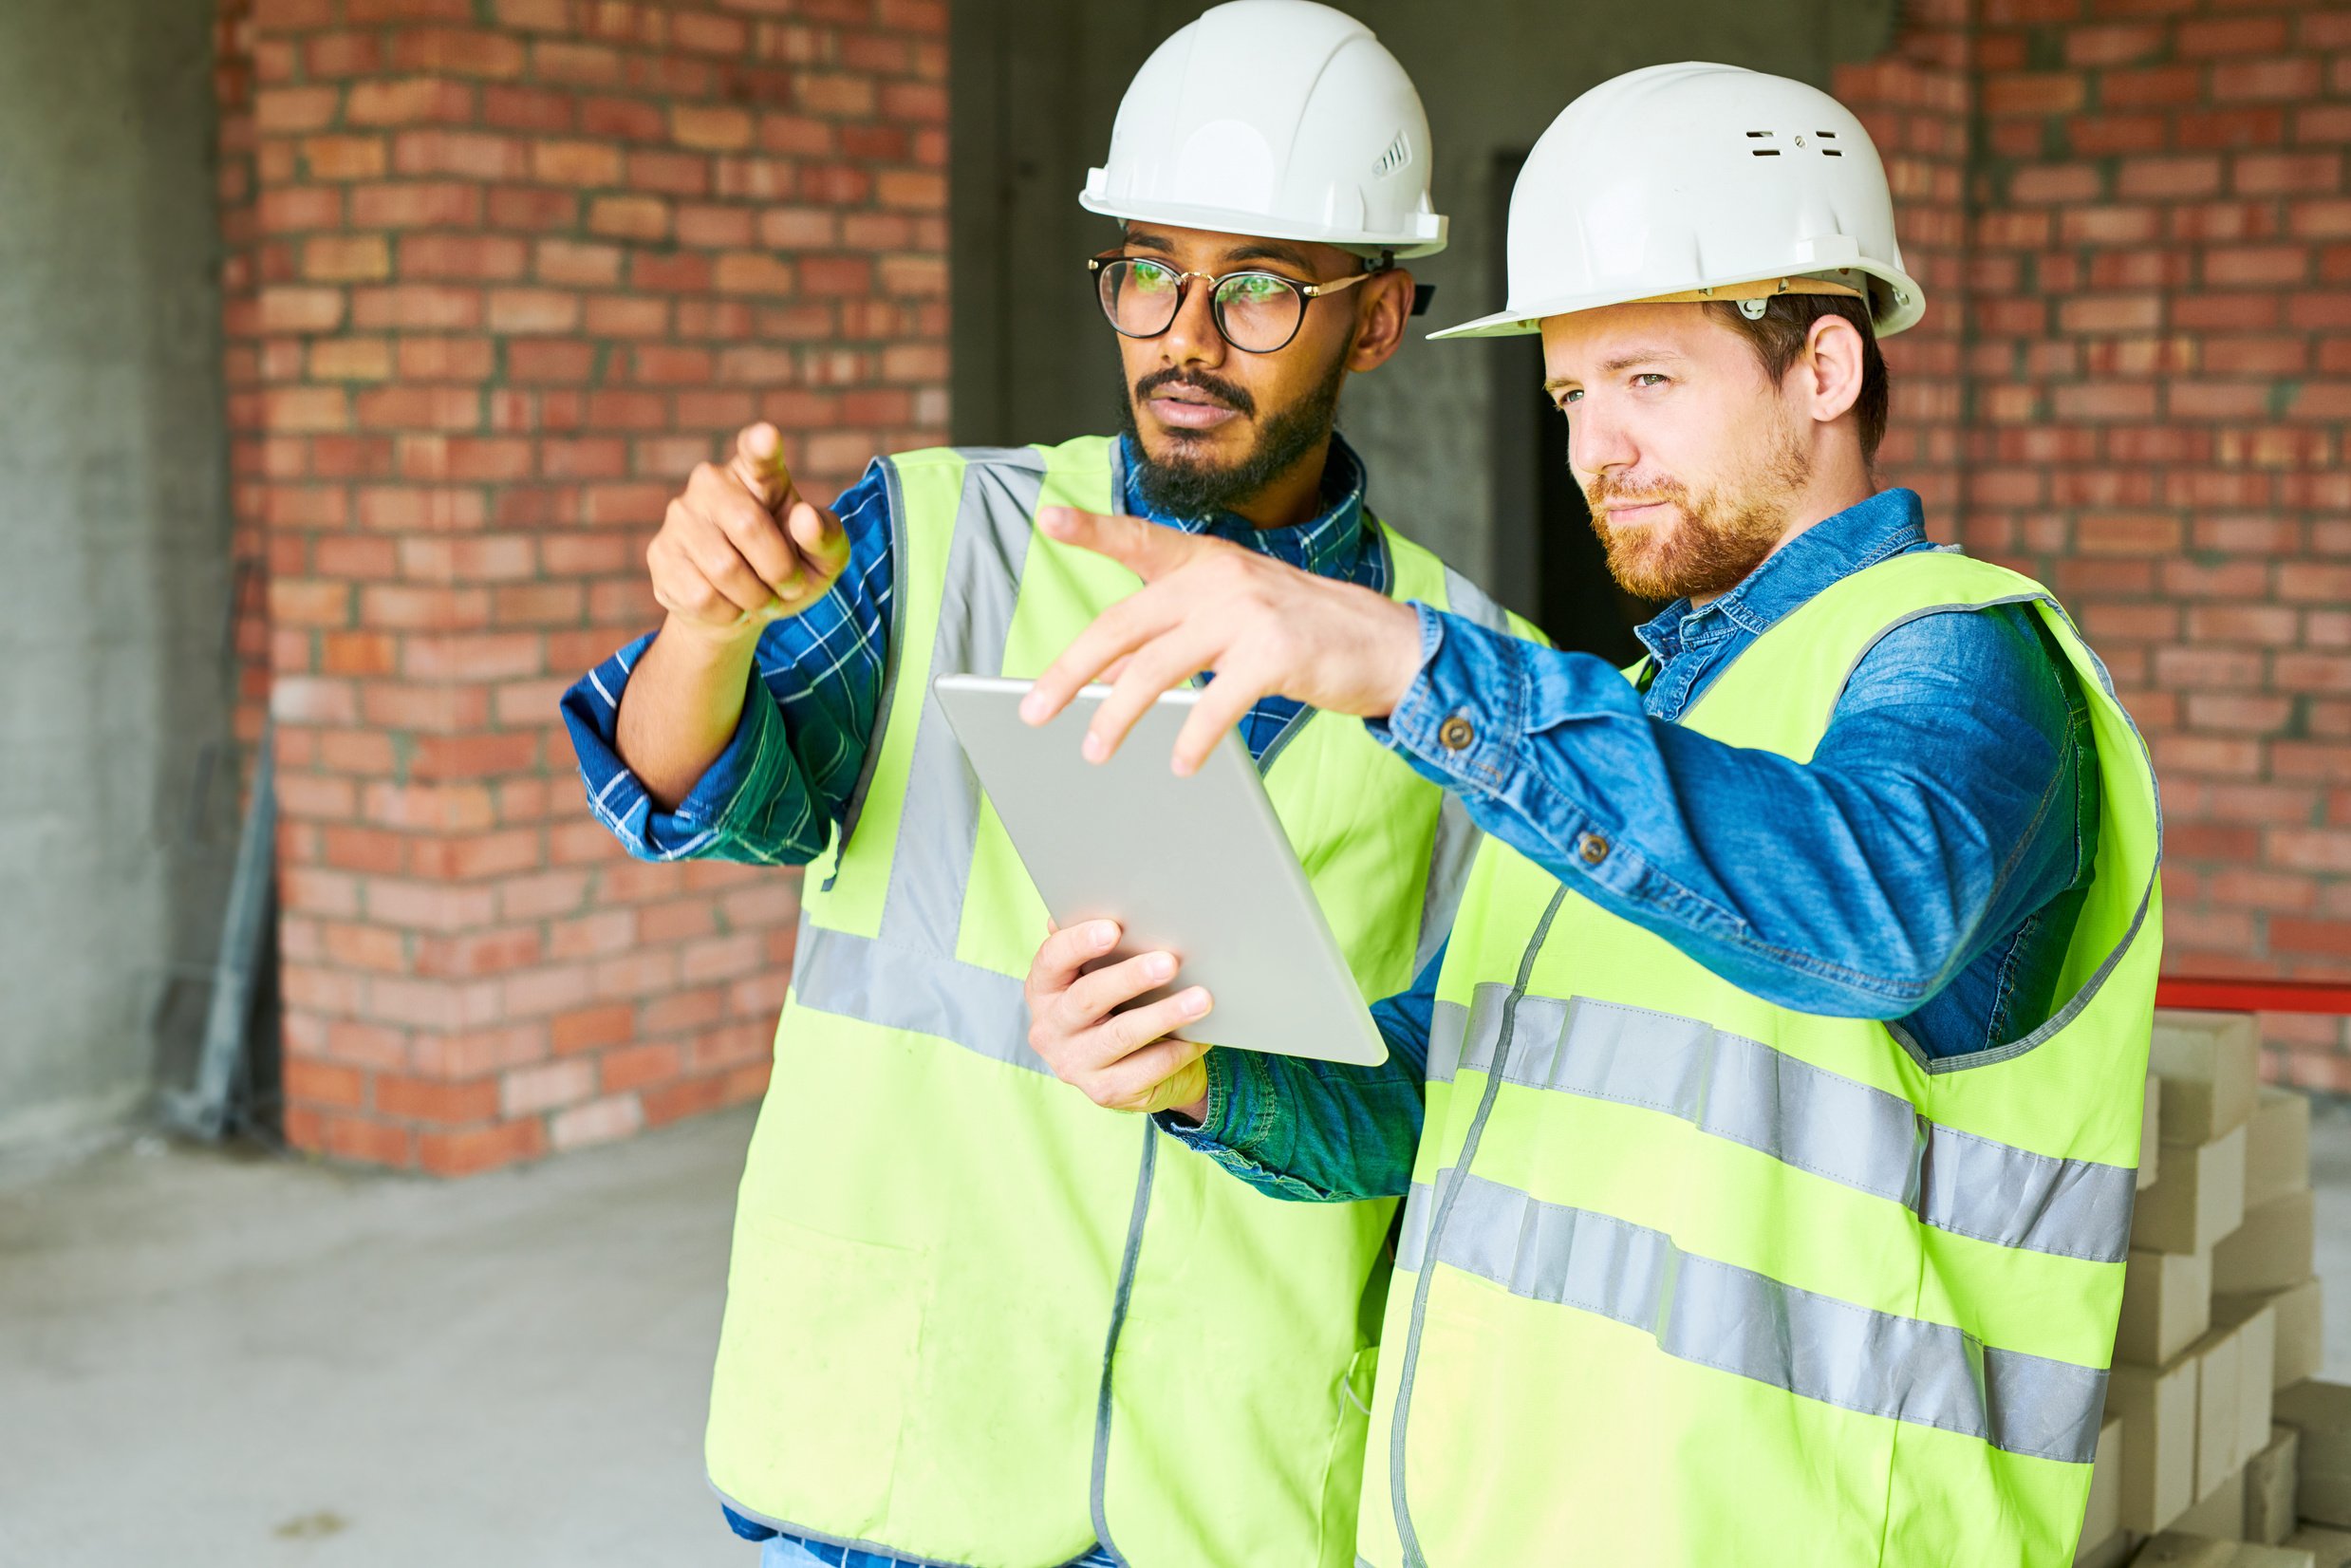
[793,917,1051,1072]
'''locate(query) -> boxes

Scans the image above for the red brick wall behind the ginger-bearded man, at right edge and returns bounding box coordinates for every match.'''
[1853,0,2351,1091]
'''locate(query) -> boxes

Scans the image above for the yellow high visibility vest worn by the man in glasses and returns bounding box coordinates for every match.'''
[708,438,1533,1568]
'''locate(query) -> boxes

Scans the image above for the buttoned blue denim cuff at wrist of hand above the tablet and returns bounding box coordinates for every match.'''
[1364,600,1528,794]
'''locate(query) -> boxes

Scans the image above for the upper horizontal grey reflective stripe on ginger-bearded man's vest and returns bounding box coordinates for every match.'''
[1429,985,2137,1262]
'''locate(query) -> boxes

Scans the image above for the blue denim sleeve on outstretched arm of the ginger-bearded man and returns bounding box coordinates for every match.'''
[1371,607,2074,1020]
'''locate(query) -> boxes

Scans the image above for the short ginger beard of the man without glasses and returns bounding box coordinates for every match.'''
[1584,425,1813,600]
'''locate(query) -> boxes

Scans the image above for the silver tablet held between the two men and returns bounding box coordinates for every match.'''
[931,675,1387,1067]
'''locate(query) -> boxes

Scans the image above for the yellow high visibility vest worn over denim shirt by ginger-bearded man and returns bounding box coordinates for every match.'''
[1359,552,2160,1568]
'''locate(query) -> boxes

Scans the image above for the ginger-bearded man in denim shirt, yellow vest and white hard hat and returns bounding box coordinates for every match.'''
[1030,64,2160,1568]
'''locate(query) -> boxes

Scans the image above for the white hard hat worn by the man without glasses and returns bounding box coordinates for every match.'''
[1429,64,1926,339]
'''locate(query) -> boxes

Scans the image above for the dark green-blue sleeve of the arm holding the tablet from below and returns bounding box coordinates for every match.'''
[1159,947,1446,1204]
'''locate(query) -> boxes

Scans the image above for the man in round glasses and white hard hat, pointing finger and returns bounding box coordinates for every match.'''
[564,0,1509,1568]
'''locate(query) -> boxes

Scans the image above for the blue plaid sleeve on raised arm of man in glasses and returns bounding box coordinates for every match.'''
[562,463,891,865]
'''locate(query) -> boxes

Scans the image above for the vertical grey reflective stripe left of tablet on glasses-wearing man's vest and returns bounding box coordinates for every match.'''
[882,447,1044,957]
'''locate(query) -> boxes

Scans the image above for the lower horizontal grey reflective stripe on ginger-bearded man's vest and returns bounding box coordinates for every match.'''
[1396,1170,2106,1465]
